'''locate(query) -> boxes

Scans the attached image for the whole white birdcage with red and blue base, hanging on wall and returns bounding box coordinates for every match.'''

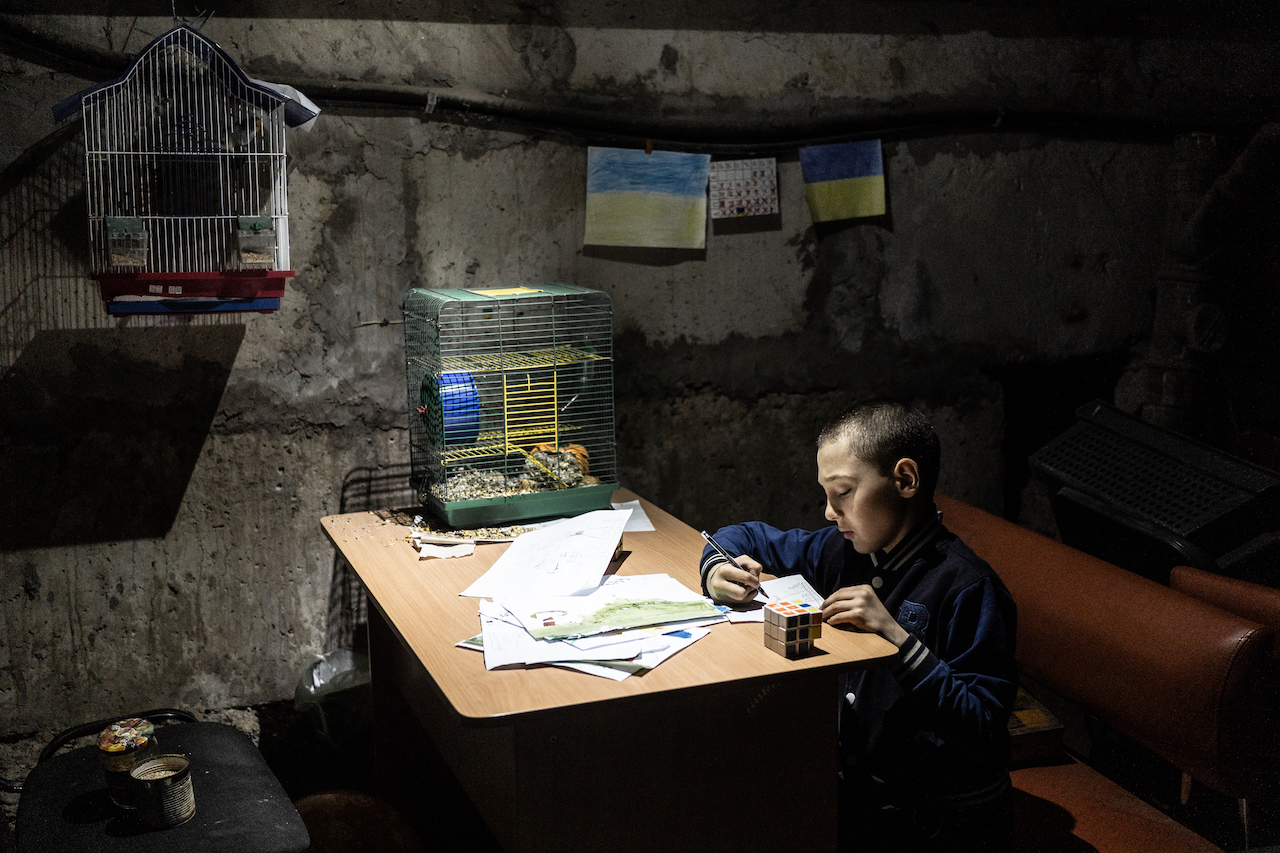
[54,24,319,314]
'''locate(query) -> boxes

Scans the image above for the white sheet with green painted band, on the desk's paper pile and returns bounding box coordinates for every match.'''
[500,571,724,639]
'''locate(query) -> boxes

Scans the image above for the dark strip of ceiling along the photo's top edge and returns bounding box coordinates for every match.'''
[3,0,1280,41]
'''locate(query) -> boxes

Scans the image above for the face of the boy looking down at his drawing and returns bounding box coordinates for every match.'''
[818,441,914,553]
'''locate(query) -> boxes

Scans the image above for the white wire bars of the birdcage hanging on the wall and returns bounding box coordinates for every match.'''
[83,28,289,273]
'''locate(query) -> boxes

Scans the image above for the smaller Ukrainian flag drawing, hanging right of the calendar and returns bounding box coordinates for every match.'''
[800,140,884,222]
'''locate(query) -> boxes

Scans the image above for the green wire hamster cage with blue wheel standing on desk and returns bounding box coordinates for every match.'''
[403,284,617,526]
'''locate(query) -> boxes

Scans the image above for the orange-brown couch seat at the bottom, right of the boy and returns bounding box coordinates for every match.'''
[1011,758,1221,853]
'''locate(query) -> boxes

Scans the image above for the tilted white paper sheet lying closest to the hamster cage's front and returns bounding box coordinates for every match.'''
[460,510,631,598]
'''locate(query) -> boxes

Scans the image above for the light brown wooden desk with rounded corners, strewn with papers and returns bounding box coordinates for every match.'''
[321,491,896,853]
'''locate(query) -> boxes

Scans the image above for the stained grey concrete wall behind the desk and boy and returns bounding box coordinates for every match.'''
[0,0,1276,734]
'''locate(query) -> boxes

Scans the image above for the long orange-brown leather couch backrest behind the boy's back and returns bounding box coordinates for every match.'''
[937,496,1274,797]
